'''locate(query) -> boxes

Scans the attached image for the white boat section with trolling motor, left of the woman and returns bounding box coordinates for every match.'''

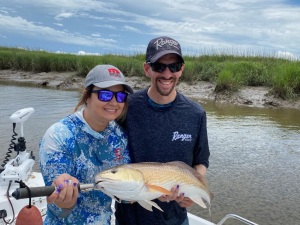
[0,108,47,225]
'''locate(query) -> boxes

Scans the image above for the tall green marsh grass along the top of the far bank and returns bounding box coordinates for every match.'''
[0,47,300,99]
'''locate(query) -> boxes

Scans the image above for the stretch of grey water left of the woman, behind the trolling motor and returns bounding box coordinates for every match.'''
[0,84,80,171]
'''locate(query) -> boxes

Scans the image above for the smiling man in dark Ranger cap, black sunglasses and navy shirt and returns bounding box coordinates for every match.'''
[116,37,210,225]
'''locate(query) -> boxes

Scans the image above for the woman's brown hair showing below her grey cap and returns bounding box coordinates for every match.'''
[74,84,129,123]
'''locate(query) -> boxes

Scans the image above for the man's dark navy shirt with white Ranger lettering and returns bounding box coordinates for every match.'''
[116,89,210,225]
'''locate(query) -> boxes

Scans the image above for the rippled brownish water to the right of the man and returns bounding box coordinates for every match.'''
[190,100,300,225]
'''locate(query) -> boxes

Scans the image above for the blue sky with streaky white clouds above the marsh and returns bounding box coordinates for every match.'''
[0,0,300,59]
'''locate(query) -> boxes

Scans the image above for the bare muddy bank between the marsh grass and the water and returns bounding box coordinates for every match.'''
[0,70,300,109]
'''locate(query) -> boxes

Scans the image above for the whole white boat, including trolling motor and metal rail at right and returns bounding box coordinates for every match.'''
[0,108,257,225]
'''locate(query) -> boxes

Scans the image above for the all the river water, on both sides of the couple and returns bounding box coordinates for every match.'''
[0,84,300,225]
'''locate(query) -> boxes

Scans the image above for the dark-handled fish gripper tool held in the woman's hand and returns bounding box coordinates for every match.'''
[12,184,95,200]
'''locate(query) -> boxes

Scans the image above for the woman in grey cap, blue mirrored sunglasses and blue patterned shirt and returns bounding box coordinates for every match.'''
[39,65,133,225]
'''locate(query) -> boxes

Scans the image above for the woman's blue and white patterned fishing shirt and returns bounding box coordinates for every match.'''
[39,110,130,225]
